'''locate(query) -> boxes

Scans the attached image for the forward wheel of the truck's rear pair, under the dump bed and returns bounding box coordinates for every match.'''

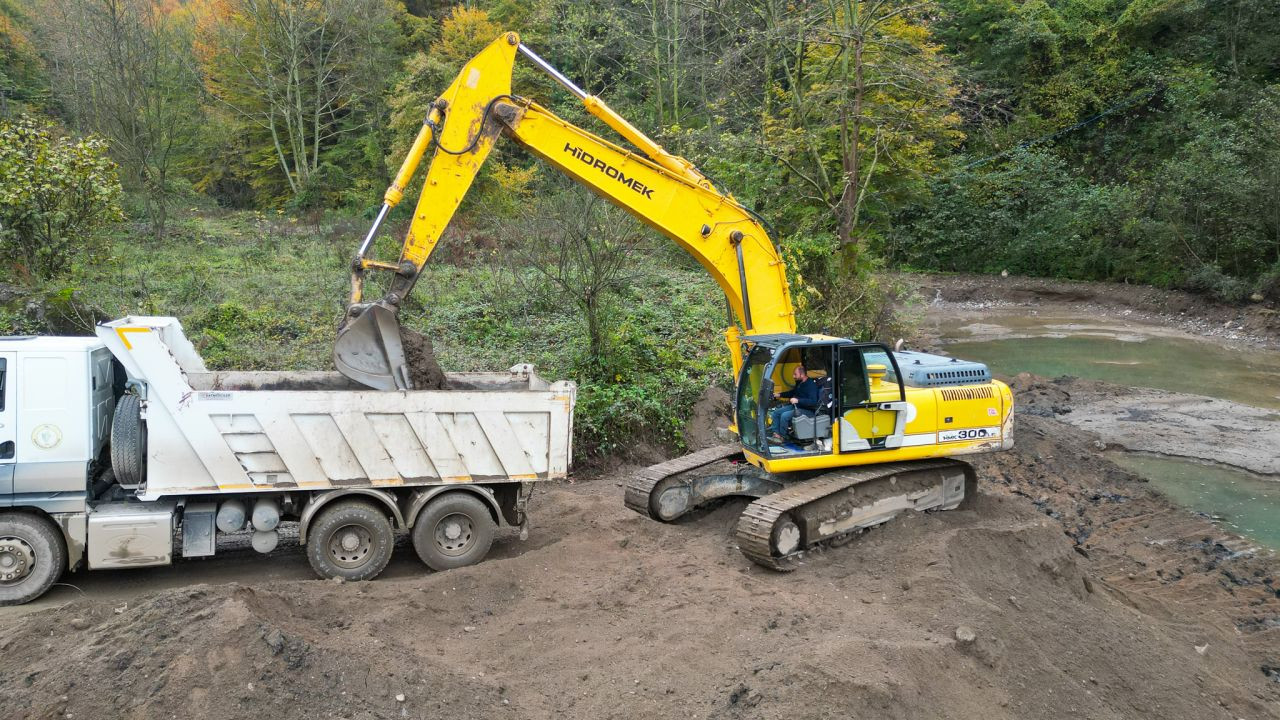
[307,500,396,580]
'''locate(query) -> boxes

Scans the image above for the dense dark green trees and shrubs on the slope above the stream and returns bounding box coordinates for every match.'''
[906,0,1280,300]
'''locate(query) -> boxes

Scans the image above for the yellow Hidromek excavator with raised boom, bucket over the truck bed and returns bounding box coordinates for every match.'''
[334,32,1014,570]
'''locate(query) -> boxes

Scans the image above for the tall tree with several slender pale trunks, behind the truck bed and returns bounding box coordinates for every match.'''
[196,0,396,199]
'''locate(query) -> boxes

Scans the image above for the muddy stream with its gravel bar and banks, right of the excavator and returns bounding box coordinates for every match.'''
[915,269,1280,550]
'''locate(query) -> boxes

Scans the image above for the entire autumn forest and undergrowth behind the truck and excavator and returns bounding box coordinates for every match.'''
[0,0,1280,454]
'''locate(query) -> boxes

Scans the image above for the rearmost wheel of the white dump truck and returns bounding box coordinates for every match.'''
[413,492,498,570]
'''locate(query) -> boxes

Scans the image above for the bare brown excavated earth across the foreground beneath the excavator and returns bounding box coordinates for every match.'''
[0,271,1280,720]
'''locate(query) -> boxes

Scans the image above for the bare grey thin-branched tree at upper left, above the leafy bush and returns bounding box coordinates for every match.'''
[40,0,201,237]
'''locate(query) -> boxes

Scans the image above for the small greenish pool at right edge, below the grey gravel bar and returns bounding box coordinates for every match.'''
[1108,452,1280,550]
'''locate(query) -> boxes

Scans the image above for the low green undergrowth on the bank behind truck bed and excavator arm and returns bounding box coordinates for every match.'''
[55,211,728,455]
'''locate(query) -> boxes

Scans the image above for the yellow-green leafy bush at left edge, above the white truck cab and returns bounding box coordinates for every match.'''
[0,117,120,279]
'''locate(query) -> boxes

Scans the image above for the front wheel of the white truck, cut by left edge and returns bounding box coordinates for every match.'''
[0,512,67,605]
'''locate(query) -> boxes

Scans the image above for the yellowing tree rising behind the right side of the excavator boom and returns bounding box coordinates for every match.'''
[765,0,961,262]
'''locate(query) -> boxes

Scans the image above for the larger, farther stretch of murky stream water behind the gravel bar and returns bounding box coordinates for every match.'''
[940,315,1280,410]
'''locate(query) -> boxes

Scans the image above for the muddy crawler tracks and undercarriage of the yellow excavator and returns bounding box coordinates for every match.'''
[626,445,977,571]
